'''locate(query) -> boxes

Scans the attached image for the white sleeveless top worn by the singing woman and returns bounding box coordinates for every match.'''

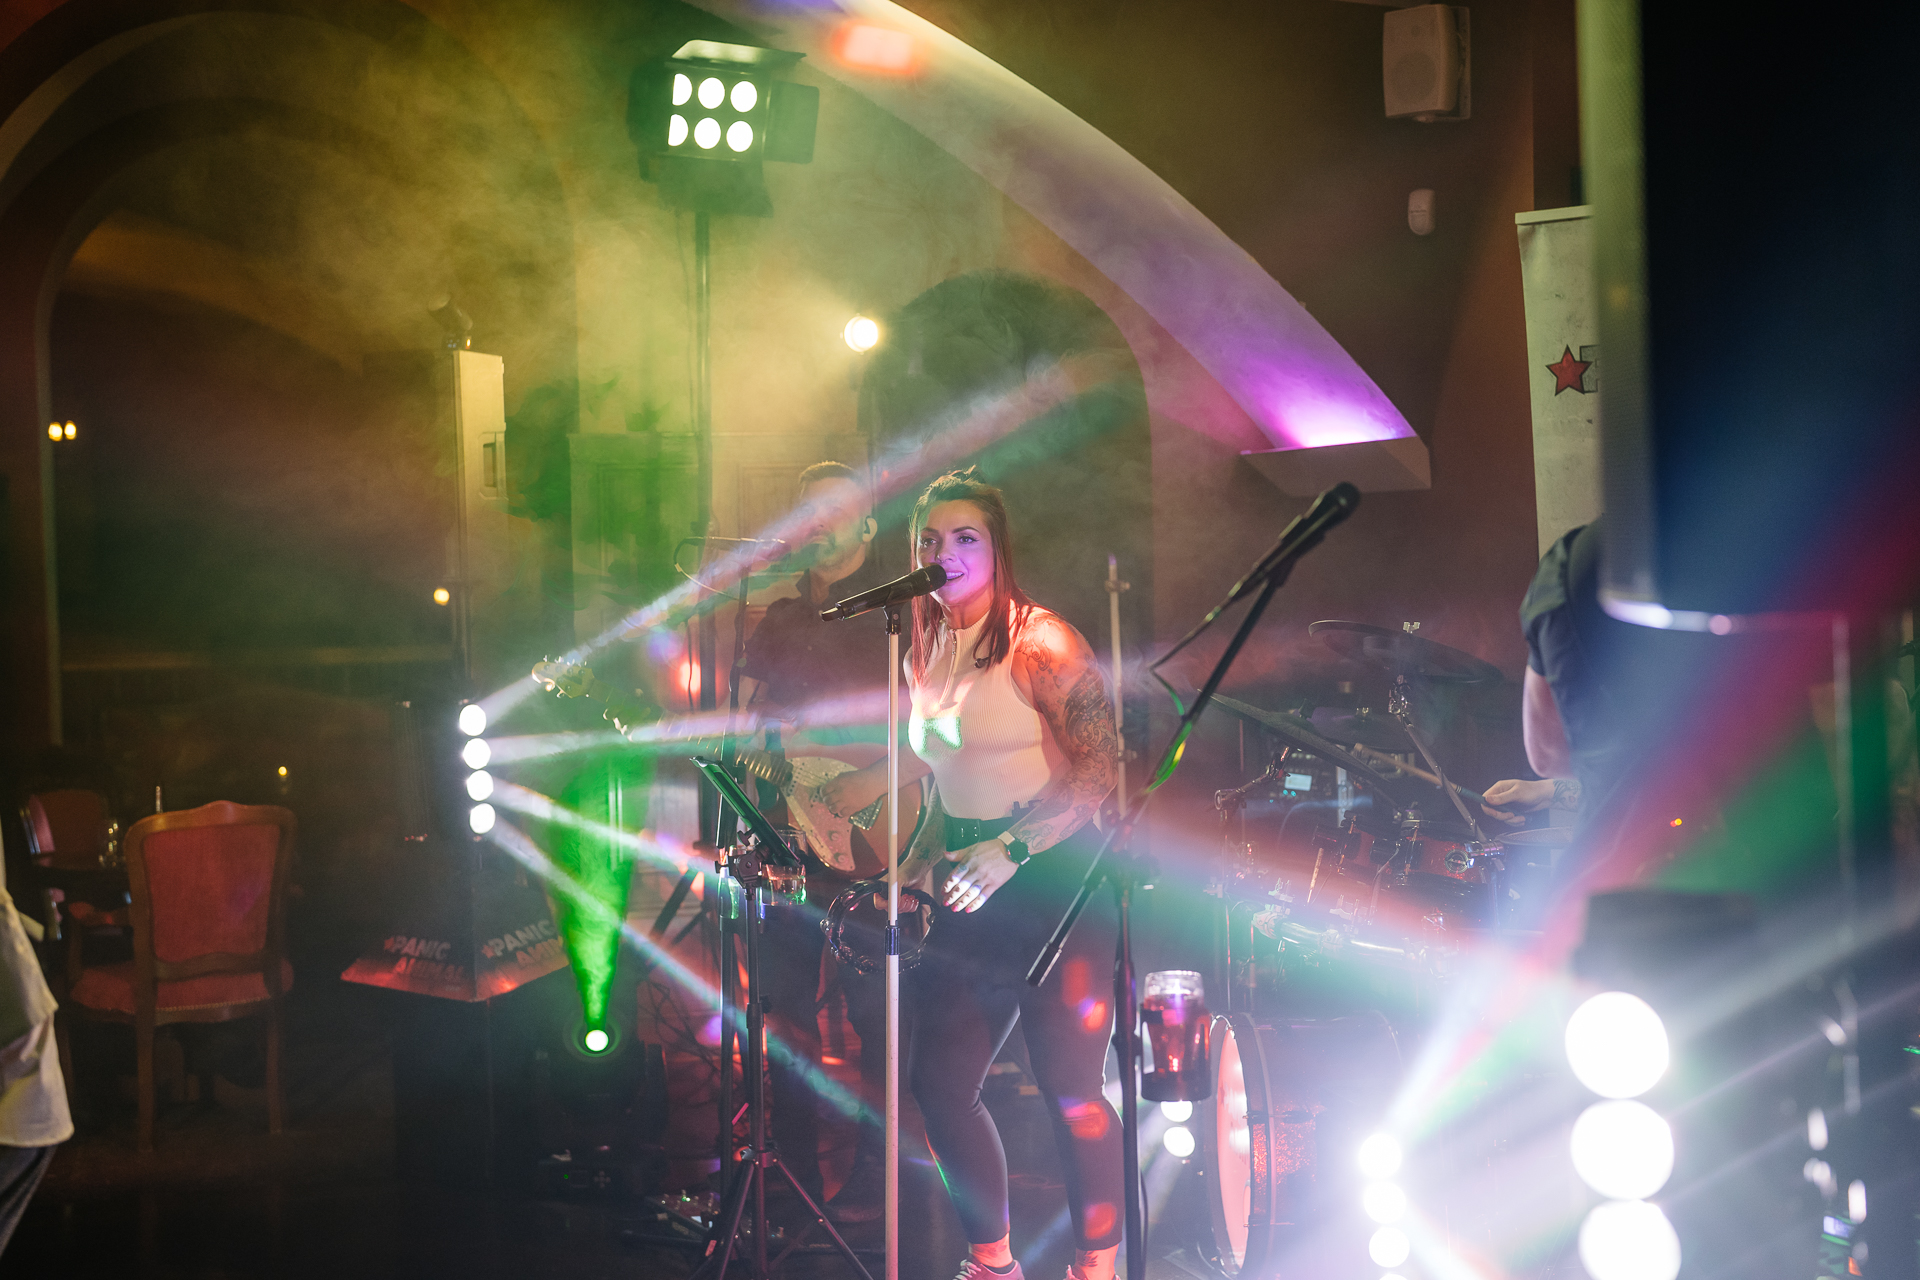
[906,608,1066,818]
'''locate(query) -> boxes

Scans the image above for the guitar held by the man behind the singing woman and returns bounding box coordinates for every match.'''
[534,662,920,879]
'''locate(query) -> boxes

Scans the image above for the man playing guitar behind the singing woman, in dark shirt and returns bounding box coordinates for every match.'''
[739,462,925,1222]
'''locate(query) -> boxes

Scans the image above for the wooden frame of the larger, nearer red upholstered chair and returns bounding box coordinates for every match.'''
[67,800,296,1151]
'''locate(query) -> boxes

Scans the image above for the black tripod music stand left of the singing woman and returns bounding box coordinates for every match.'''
[693,756,874,1280]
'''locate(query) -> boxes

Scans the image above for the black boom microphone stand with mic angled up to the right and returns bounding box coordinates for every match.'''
[1029,484,1359,1280]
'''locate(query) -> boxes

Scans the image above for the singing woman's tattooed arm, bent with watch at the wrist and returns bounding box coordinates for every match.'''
[1014,616,1119,854]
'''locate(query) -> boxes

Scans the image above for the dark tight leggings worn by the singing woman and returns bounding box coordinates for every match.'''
[906,831,1125,1249]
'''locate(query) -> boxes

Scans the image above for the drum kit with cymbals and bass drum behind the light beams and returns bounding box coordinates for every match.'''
[1196,622,1571,1278]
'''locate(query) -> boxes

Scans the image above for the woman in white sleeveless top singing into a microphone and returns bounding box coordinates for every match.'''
[902,468,1123,1280]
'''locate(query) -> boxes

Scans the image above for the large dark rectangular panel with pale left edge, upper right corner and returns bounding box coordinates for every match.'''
[1580,0,1920,631]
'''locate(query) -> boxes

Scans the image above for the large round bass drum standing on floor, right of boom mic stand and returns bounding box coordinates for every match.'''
[1194,1011,1400,1280]
